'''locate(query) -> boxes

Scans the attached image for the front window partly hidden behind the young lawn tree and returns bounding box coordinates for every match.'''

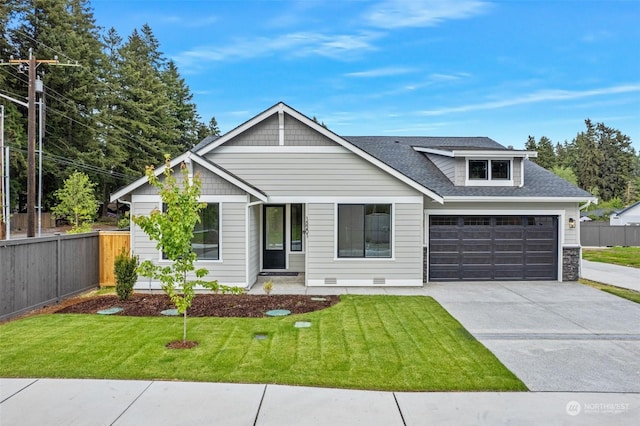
[162,203,220,260]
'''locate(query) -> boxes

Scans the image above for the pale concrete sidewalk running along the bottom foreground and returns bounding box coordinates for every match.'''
[0,379,640,426]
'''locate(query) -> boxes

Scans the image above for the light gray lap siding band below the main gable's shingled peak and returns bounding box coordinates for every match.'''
[208,152,417,197]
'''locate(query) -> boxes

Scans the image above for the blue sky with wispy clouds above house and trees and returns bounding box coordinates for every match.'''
[91,0,640,151]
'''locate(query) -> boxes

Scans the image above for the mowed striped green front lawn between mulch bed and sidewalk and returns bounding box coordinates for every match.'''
[0,295,526,391]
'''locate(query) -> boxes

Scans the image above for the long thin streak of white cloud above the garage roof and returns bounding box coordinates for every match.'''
[420,84,640,116]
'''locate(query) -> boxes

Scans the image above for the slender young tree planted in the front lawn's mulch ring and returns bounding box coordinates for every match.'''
[132,156,207,342]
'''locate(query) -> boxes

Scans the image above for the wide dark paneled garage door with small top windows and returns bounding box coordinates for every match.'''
[429,216,558,281]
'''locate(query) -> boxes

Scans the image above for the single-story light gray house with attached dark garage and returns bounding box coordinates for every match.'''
[111,103,595,288]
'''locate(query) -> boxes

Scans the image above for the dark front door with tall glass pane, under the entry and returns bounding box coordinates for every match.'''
[262,205,286,269]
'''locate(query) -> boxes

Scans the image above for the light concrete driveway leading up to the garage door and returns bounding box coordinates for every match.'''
[427,282,640,392]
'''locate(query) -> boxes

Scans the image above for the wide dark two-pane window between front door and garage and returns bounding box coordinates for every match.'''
[338,204,391,258]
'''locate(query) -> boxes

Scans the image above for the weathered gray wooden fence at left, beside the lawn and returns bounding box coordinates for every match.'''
[0,232,100,320]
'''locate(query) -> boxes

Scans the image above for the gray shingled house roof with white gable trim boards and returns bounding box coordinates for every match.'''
[111,102,597,204]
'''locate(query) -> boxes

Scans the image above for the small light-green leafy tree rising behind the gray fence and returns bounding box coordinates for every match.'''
[51,172,98,232]
